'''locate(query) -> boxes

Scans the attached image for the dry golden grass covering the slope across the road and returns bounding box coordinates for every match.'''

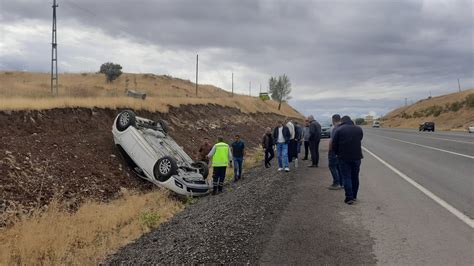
[382,89,474,131]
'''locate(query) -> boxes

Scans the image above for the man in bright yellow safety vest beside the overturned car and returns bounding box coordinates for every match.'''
[207,137,232,195]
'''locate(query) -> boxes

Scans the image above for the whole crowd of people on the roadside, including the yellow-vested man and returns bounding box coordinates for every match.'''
[198,114,363,204]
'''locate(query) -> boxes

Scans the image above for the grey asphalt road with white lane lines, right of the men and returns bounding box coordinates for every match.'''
[360,128,474,265]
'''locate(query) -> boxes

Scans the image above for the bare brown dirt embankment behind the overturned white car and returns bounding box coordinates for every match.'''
[0,105,283,227]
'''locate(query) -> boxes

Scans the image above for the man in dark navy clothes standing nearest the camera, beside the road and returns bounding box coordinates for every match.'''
[331,116,364,205]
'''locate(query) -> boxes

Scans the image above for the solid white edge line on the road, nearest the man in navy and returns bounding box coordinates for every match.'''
[362,147,474,228]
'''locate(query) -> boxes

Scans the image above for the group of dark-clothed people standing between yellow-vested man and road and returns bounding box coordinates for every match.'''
[262,114,363,204]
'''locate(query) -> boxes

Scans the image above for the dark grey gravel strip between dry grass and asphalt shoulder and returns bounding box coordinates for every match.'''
[106,168,295,264]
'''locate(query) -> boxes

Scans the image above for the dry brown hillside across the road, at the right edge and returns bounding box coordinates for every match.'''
[381,89,474,130]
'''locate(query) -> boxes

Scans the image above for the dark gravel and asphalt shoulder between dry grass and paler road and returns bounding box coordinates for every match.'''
[106,142,376,265]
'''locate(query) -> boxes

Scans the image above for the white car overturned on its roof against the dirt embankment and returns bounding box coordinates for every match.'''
[112,110,211,196]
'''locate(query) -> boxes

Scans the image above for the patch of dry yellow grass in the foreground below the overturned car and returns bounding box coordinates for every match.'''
[0,190,183,265]
